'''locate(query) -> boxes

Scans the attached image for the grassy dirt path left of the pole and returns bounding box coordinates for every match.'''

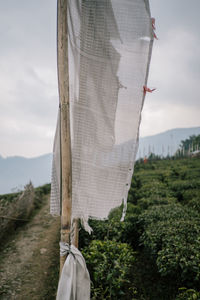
[0,200,60,300]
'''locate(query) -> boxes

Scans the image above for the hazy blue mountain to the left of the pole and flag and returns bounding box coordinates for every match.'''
[0,154,52,194]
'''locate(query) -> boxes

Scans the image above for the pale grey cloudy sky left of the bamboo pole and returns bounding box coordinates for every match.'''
[0,0,58,156]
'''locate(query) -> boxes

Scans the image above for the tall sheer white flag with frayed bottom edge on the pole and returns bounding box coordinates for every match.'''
[51,0,153,227]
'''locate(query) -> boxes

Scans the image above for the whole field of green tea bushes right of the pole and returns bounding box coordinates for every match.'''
[80,157,200,300]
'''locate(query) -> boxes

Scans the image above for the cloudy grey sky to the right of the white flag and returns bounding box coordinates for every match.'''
[140,0,200,136]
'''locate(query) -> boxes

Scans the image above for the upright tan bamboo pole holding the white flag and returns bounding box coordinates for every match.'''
[57,0,72,274]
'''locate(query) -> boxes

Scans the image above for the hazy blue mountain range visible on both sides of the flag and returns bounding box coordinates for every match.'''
[0,127,200,194]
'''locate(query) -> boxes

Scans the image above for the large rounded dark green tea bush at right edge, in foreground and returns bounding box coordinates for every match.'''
[140,204,200,286]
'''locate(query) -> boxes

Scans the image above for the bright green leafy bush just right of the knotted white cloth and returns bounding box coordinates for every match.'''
[83,240,136,300]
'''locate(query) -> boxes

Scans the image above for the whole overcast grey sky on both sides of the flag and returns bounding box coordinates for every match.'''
[0,0,200,157]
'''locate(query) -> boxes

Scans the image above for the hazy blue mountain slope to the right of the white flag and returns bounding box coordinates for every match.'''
[137,127,200,158]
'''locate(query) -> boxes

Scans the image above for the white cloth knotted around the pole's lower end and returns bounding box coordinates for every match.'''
[56,242,90,300]
